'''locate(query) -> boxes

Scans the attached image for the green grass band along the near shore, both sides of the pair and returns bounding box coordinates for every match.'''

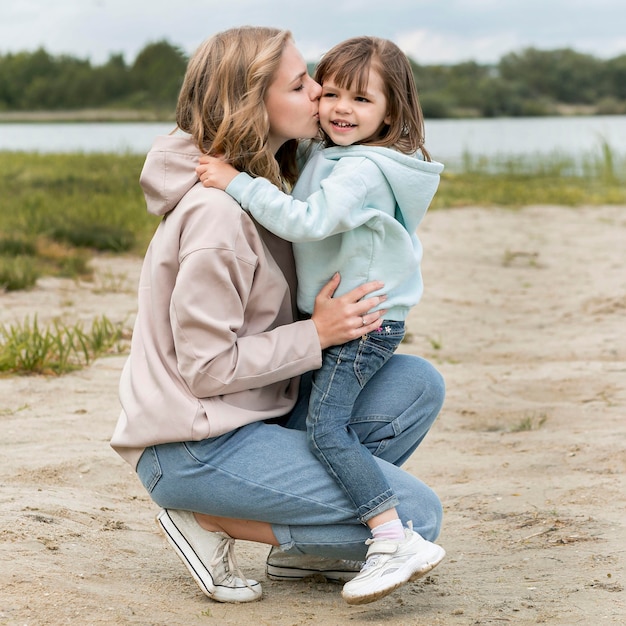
[0,142,626,276]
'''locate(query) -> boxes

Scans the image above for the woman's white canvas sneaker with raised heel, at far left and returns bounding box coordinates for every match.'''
[156,509,262,602]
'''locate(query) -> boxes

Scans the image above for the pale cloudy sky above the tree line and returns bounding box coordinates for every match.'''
[0,0,626,65]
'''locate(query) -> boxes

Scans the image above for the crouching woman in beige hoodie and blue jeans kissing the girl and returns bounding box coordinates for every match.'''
[111,27,444,602]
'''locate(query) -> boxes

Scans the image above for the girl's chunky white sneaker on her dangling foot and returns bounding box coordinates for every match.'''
[341,522,446,604]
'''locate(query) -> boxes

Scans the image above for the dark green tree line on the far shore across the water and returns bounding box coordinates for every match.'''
[0,40,626,118]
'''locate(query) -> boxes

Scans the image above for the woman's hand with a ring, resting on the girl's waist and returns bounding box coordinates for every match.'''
[311,273,387,349]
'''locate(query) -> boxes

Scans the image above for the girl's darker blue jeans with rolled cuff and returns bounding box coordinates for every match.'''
[306,320,404,523]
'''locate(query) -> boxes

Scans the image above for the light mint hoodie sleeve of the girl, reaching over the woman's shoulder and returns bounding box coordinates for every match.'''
[226,157,386,242]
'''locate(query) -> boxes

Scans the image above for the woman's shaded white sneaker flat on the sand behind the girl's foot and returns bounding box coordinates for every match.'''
[265,547,363,583]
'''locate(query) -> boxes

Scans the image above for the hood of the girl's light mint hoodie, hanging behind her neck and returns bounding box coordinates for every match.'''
[324,145,443,233]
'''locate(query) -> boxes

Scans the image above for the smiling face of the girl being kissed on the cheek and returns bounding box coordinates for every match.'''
[319,69,389,146]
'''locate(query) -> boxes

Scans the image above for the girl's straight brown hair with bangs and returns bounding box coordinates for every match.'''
[314,37,430,161]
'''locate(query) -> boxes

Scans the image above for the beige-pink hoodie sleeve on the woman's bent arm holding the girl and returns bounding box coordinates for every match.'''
[170,197,321,398]
